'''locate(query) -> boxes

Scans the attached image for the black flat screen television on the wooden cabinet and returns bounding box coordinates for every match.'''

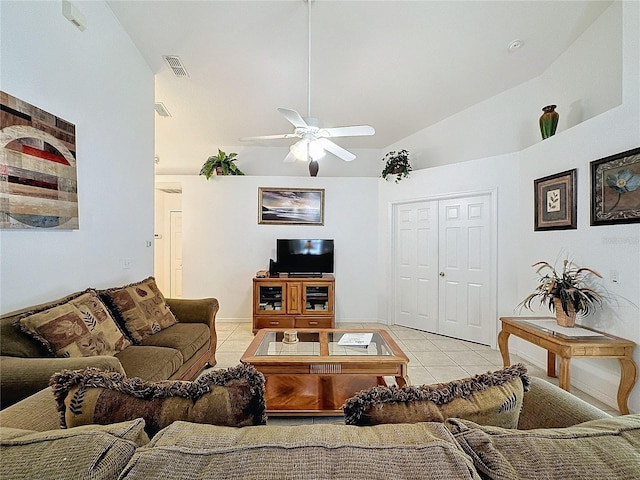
[276,238,334,275]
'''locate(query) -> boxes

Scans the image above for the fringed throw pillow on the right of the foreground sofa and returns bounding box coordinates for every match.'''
[344,364,529,428]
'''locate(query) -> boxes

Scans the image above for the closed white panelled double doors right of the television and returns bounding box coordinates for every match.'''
[392,193,497,345]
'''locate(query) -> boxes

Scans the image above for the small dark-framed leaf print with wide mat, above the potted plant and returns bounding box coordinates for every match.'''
[533,168,576,231]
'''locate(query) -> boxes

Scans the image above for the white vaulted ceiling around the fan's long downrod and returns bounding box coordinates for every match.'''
[108,0,611,173]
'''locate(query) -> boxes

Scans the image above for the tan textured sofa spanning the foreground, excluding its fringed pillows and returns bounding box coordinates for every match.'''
[0,378,640,480]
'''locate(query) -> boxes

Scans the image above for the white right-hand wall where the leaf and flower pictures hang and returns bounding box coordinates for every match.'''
[514,2,640,412]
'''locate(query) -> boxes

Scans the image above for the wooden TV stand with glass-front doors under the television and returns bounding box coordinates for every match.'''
[253,273,336,333]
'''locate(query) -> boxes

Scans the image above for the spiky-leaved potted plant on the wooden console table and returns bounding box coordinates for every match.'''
[518,259,603,327]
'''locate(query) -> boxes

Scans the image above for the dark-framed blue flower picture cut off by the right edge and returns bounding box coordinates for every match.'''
[591,148,640,225]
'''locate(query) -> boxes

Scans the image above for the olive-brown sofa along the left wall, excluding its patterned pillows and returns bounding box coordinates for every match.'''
[0,292,218,409]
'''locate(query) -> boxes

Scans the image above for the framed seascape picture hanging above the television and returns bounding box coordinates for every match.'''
[258,187,324,225]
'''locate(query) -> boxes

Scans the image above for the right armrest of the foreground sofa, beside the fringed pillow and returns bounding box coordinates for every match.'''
[518,377,611,430]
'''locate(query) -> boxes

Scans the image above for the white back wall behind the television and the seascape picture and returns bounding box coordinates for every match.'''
[157,175,378,322]
